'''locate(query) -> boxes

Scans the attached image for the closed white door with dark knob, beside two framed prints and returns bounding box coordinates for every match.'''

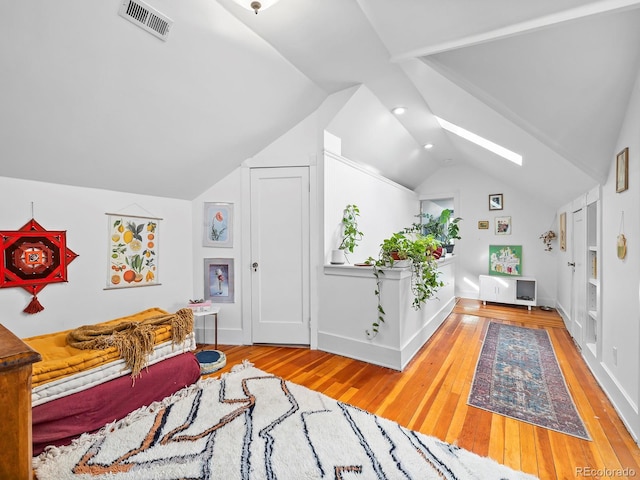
[251,167,310,345]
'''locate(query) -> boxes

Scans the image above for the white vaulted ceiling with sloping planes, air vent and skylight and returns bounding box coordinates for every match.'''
[0,0,640,205]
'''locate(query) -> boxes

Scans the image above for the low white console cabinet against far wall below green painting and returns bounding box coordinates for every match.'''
[480,275,538,310]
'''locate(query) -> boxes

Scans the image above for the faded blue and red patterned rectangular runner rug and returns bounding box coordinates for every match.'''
[468,322,591,440]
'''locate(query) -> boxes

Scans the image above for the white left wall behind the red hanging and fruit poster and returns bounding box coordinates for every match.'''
[0,177,193,337]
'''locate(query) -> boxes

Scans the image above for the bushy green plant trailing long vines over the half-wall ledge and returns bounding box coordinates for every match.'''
[365,227,444,338]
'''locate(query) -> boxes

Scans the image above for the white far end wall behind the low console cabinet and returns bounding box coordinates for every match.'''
[416,166,558,305]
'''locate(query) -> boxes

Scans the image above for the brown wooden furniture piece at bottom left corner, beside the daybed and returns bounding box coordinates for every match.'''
[0,325,41,480]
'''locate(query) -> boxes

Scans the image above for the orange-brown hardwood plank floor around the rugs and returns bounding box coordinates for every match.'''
[205,299,640,480]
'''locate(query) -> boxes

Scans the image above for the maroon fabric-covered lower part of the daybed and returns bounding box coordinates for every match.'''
[32,352,200,455]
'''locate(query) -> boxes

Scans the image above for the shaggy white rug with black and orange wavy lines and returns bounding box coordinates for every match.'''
[34,363,534,480]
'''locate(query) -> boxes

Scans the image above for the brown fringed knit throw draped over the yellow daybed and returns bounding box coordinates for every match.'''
[67,308,193,378]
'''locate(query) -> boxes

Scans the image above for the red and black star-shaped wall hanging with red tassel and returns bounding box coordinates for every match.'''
[0,218,78,314]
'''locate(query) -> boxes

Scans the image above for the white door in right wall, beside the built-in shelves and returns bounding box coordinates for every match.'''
[571,209,587,348]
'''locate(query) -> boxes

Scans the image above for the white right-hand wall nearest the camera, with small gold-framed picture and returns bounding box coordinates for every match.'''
[601,64,640,438]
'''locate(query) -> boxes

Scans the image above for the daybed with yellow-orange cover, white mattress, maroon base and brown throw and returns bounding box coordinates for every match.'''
[23,308,200,455]
